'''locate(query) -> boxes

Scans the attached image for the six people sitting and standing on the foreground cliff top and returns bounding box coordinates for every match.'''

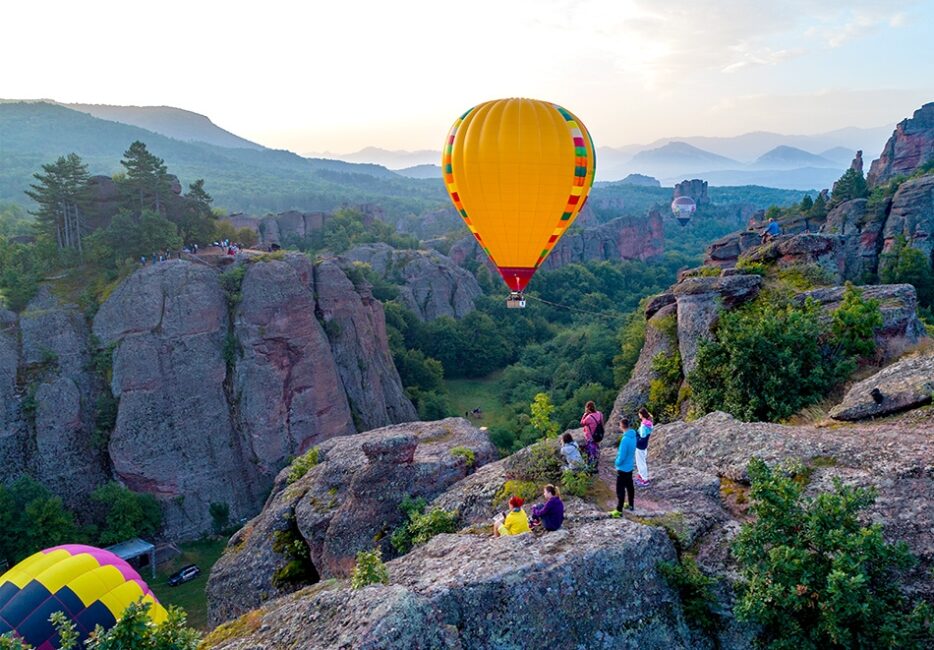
[493,401,654,537]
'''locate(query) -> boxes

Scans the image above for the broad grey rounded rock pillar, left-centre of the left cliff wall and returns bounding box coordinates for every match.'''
[94,261,268,537]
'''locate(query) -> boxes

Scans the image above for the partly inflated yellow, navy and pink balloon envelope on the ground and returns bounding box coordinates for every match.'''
[0,544,167,650]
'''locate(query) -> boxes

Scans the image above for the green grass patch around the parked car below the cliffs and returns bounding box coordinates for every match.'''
[153,537,227,630]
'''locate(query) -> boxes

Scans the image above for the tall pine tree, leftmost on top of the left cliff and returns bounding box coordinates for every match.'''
[26,153,90,254]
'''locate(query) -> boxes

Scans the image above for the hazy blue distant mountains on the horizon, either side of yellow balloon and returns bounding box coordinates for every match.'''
[318,126,894,190]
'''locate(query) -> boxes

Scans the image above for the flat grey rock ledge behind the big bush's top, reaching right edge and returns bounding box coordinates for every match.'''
[792,284,926,361]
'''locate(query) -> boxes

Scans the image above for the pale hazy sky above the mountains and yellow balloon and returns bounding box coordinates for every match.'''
[0,0,934,152]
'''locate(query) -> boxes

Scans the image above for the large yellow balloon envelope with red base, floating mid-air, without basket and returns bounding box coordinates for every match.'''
[441,99,595,304]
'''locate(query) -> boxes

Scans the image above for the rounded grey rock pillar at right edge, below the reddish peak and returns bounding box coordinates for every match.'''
[879,172,934,267]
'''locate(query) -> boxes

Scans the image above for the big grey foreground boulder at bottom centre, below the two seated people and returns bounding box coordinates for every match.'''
[208,518,696,650]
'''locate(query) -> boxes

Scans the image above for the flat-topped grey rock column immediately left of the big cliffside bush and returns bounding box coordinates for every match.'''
[673,275,762,377]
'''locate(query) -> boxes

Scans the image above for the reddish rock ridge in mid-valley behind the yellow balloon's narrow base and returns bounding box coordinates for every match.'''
[451,211,665,276]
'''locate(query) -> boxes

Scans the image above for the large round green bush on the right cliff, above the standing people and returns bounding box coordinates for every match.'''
[688,299,853,421]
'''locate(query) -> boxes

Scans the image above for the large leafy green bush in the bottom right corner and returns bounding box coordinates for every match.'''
[733,459,934,649]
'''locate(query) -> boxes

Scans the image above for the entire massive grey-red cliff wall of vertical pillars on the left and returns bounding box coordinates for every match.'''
[0,254,416,539]
